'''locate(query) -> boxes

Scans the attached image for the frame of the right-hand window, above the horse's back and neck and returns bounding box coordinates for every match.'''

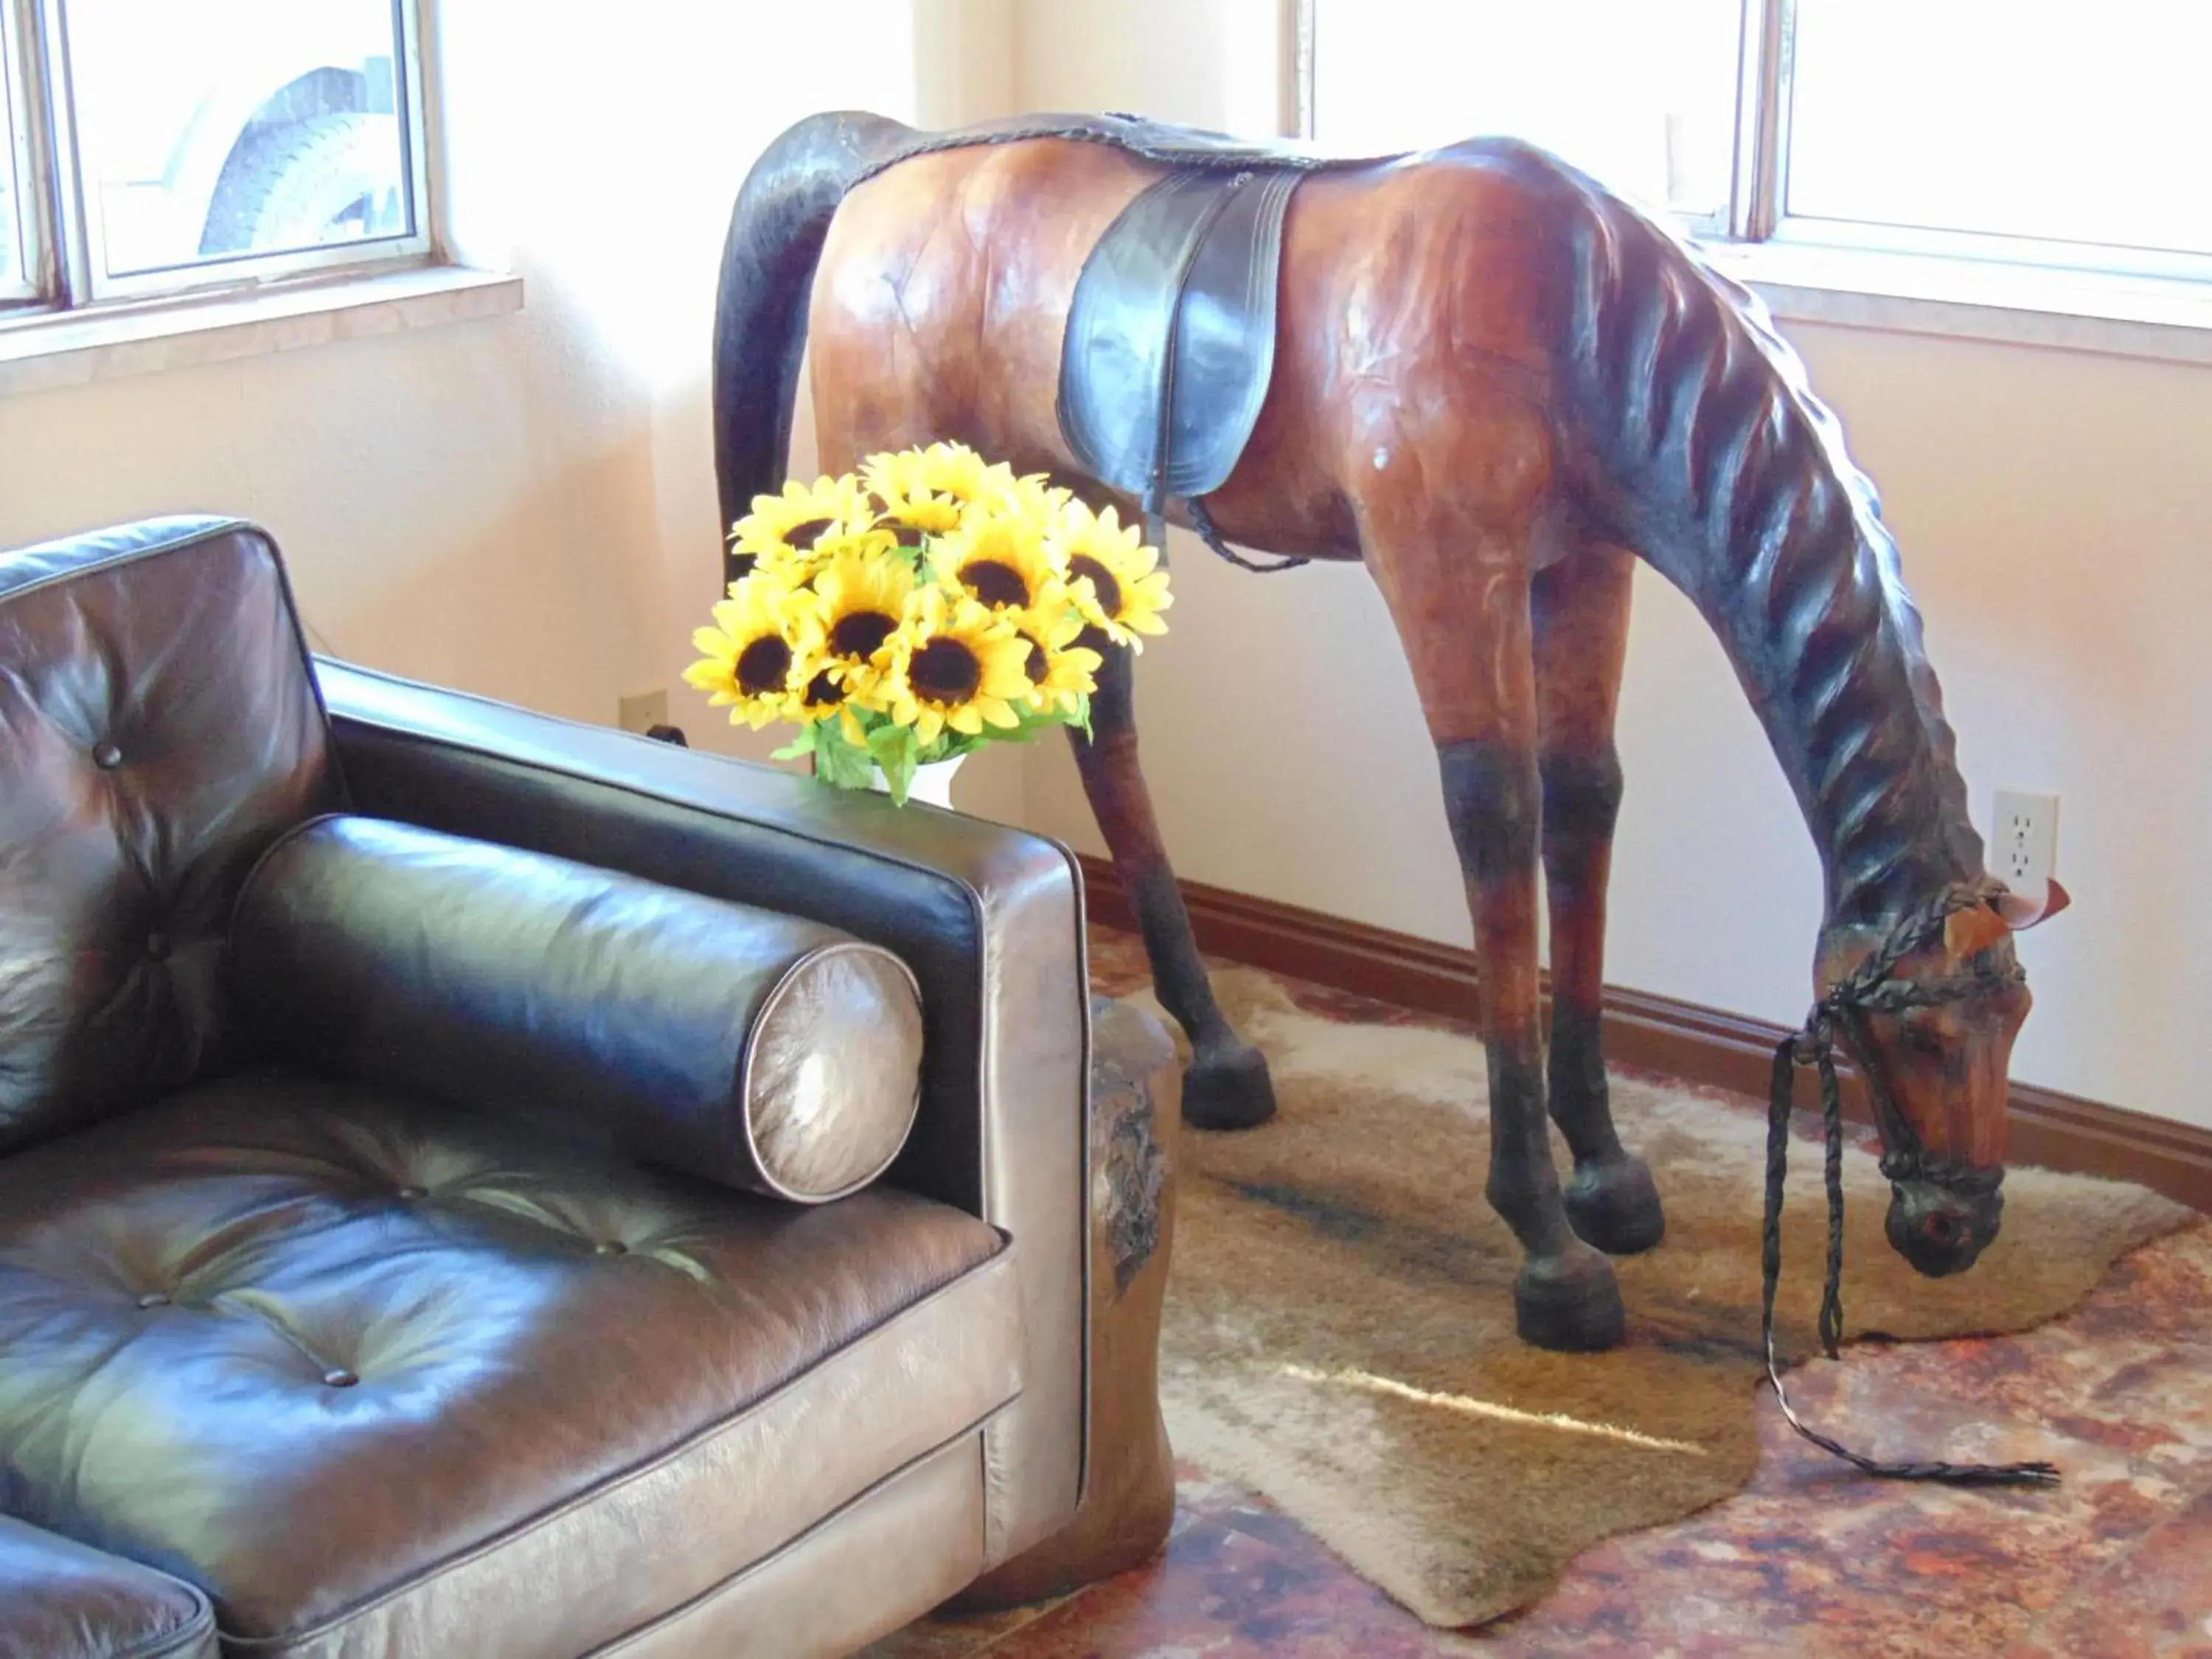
[1285,0,2212,303]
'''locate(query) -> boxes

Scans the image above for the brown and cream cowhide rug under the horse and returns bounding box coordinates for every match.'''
[1161,969,2190,1626]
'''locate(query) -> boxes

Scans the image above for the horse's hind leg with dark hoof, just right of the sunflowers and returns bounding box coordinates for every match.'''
[1068,646,1274,1128]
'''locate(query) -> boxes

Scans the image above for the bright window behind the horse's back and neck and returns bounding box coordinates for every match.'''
[1305,0,2212,292]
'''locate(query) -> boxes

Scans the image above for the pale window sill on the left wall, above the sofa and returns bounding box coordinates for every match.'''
[0,265,522,396]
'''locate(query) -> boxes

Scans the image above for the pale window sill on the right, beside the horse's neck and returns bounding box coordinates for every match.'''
[1705,241,2212,365]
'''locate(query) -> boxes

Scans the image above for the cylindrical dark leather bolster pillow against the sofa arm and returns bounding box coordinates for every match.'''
[230,816,922,1203]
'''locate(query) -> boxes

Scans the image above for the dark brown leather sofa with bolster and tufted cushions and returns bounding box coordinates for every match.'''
[0,518,1088,1659]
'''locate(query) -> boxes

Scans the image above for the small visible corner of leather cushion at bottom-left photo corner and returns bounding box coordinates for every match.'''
[0,1515,215,1659]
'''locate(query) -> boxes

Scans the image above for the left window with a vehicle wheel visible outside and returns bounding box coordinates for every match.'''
[0,0,429,323]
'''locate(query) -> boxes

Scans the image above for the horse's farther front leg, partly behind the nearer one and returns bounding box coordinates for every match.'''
[1531,544,1666,1256]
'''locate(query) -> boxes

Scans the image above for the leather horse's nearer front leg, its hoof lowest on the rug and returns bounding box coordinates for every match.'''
[1367,515,1626,1352]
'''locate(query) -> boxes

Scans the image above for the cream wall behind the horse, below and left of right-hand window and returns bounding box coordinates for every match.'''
[1020,0,2212,1124]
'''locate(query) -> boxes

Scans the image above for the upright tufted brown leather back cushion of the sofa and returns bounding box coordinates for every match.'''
[0,520,336,1155]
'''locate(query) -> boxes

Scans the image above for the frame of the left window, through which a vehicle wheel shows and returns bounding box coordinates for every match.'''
[0,0,438,330]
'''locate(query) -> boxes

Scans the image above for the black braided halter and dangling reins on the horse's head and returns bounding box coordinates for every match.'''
[1759,883,2059,1486]
